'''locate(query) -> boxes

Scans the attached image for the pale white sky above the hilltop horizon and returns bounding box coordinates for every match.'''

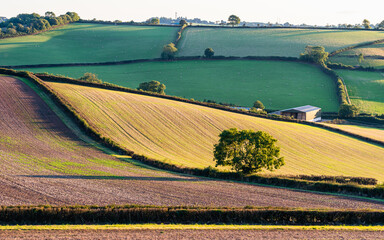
[0,0,384,25]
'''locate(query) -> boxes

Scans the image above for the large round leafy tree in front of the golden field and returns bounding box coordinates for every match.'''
[214,128,285,174]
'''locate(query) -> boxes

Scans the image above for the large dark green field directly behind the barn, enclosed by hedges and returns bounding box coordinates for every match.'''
[25,60,338,112]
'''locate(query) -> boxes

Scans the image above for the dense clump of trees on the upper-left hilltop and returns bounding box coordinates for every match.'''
[0,12,80,37]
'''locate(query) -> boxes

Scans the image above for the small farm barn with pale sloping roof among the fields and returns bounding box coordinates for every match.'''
[272,105,321,122]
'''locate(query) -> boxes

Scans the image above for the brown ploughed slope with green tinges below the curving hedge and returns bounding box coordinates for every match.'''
[0,77,384,209]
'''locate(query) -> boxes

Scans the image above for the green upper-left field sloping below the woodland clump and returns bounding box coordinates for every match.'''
[0,23,178,65]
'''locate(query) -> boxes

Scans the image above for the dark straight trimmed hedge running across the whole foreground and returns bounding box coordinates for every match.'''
[0,206,384,226]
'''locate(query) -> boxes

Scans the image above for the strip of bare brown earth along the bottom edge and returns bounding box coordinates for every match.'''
[0,230,384,240]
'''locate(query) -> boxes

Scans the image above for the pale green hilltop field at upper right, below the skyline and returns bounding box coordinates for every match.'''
[179,28,384,57]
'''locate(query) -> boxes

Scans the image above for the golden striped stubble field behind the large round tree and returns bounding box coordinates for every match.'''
[49,83,384,181]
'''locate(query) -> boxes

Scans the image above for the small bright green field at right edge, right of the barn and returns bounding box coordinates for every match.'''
[337,70,384,114]
